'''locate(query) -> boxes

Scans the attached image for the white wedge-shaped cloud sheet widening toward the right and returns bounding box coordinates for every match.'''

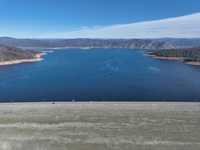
[42,13,200,38]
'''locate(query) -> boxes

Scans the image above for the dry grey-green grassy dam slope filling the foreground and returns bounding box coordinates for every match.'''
[0,103,200,150]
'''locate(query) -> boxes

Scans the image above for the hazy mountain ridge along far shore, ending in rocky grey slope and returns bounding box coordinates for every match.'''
[0,37,177,49]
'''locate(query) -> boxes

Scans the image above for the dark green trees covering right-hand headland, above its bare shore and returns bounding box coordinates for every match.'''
[150,48,200,62]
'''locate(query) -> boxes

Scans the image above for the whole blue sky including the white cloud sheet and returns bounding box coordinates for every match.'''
[0,0,200,38]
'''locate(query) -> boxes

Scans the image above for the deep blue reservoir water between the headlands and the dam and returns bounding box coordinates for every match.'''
[0,49,200,102]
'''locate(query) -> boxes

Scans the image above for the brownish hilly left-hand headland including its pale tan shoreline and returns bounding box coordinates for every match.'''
[0,45,45,66]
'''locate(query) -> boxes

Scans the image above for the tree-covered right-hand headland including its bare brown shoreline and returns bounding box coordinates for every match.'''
[146,47,200,65]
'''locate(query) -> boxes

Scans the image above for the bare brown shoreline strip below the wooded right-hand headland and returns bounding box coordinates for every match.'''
[144,53,200,66]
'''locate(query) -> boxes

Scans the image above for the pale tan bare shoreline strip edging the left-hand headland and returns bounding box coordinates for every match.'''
[0,52,46,66]
